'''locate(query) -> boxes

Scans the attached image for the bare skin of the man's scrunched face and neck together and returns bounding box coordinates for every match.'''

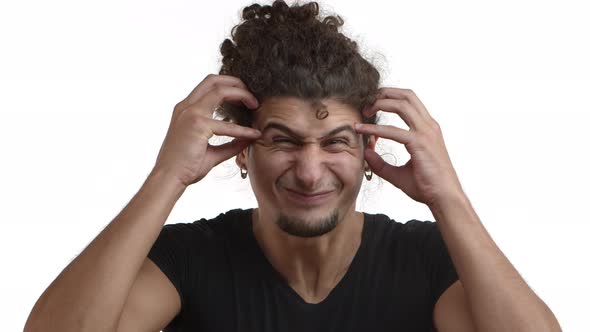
[236,97,375,303]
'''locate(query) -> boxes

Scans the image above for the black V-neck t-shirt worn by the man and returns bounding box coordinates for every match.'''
[148,209,458,332]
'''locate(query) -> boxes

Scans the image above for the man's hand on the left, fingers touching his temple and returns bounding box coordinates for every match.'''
[152,74,260,187]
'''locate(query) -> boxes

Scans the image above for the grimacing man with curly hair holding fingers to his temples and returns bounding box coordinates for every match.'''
[25,1,560,331]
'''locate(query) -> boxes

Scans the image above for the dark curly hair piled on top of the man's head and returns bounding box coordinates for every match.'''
[217,0,380,144]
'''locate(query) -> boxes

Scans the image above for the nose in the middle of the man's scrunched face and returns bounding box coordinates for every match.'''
[294,144,326,192]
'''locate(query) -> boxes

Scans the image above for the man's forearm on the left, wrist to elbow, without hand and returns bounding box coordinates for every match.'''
[25,173,184,331]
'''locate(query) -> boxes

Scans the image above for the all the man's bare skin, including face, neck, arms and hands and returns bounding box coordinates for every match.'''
[25,75,561,332]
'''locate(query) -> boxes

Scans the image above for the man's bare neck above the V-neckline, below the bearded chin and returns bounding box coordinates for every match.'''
[252,206,364,302]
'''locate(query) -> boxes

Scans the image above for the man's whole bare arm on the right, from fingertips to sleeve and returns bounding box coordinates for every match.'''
[356,88,560,331]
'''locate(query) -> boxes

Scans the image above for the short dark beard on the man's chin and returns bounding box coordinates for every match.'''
[276,210,340,238]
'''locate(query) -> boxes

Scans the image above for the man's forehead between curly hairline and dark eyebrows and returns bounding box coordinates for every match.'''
[253,97,362,130]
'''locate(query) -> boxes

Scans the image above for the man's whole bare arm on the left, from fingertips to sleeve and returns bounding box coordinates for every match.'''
[25,75,260,332]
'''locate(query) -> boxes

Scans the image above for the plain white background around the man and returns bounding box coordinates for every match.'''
[0,0,590,331]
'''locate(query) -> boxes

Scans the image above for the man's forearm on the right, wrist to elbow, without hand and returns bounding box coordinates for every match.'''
[430,193,561,332]
